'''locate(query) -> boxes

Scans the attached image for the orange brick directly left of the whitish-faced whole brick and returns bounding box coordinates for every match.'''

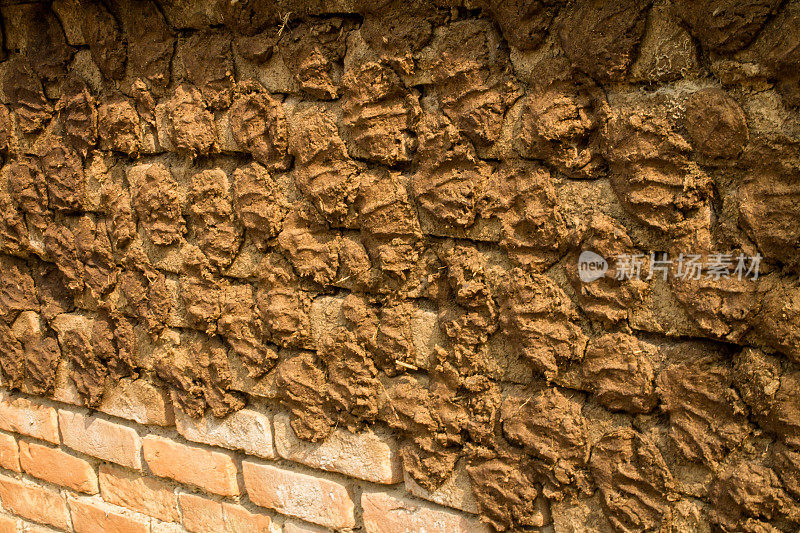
[142,435,239,496]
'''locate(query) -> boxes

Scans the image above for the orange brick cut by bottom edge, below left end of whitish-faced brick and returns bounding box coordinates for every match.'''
[180,494,272,533]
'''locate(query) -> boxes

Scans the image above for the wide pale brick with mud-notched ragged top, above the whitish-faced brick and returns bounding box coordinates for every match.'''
[274,413,403,484]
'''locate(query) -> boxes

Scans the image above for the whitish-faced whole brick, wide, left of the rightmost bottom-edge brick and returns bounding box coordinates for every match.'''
[242,461,355,528]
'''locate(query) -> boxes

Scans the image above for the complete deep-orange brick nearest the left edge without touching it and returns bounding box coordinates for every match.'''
[19,441,98,494]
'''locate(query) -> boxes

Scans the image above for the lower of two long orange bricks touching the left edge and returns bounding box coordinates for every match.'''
[0,475,69,529]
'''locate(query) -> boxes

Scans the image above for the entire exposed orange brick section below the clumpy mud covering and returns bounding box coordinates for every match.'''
[0,390,494,533]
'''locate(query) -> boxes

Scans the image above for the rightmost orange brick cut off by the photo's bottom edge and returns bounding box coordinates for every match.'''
[361,491,489,533]
